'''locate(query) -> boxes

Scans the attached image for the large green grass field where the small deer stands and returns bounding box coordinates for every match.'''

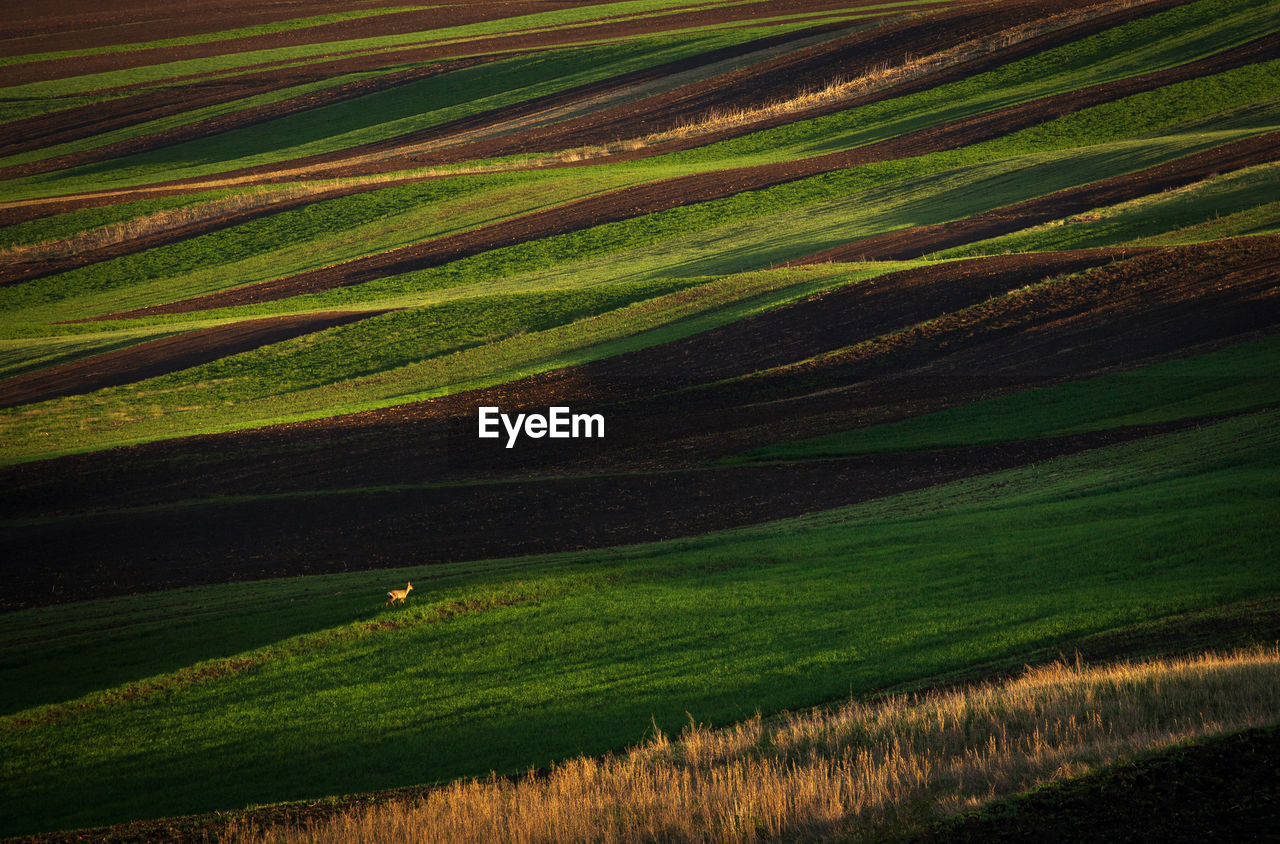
[0,412,1280,832]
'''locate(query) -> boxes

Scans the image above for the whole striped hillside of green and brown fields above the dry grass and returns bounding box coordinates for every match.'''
[0,0,1280,840]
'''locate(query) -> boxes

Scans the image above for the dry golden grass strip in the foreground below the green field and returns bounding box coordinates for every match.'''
[228,648,1280,844]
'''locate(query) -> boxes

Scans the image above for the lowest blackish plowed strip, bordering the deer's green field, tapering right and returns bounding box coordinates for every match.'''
[0,426,1218,610]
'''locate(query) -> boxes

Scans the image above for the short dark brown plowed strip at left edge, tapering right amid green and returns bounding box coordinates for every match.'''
[0,311,385,407]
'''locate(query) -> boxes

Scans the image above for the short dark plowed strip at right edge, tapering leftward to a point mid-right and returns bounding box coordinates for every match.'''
[790,132,1280,266]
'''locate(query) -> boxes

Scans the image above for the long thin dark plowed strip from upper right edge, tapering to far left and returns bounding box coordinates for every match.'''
[95,30,1280,319]
